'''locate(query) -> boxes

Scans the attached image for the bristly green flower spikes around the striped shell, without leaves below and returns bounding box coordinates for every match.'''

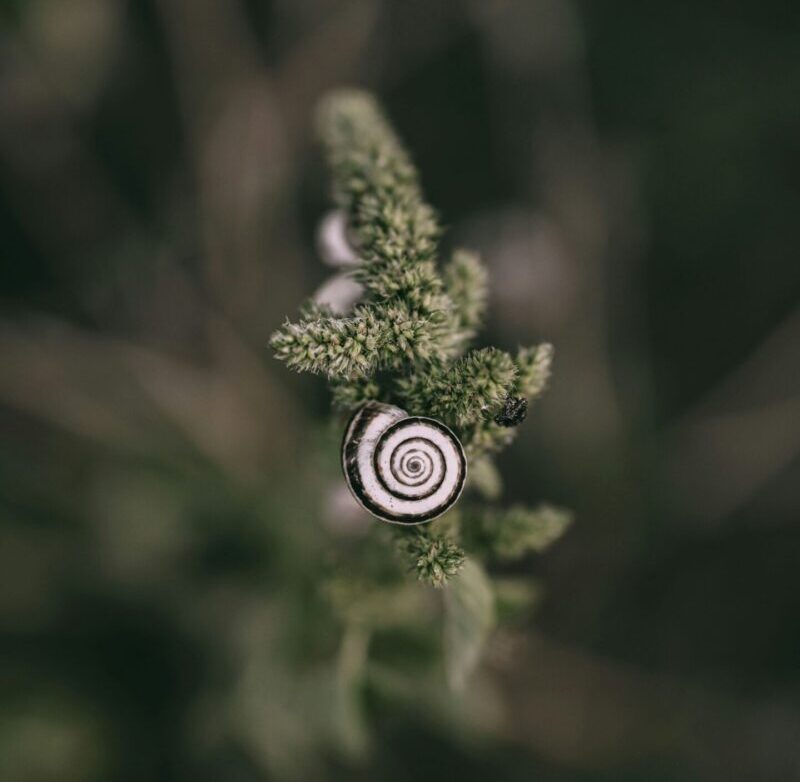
[271,90,570,587]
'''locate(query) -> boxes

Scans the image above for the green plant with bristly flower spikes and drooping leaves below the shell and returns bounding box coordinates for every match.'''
[271,90,571,700]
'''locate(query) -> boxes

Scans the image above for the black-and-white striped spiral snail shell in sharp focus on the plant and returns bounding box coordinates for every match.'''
[342,402,467,524]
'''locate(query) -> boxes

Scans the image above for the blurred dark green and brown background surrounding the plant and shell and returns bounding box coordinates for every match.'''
[0,0,800,782]
